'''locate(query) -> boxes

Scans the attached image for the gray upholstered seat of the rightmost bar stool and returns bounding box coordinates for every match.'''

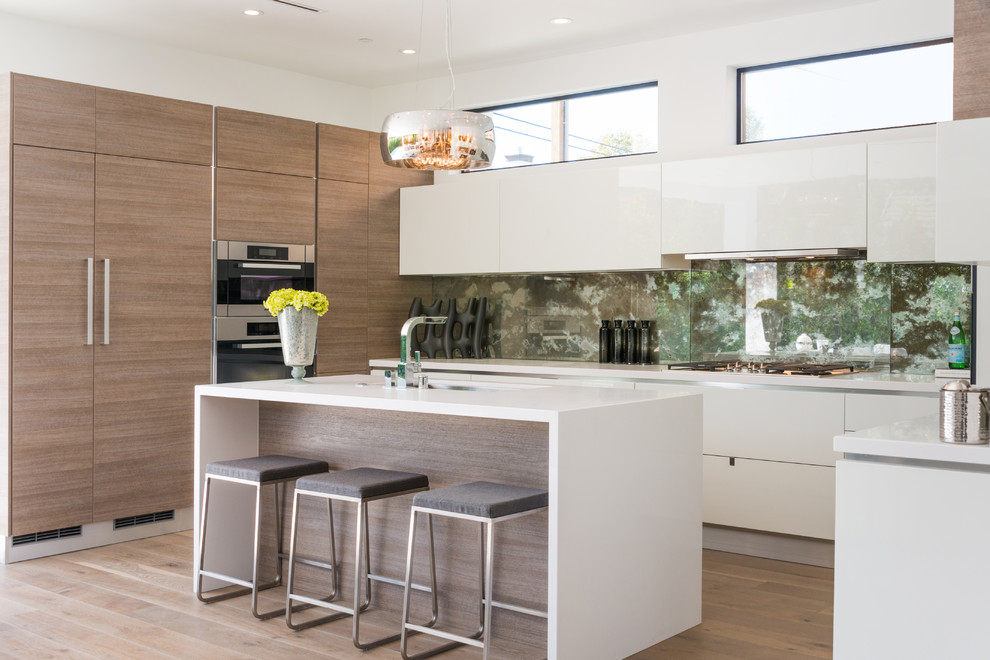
[413,481,550,518]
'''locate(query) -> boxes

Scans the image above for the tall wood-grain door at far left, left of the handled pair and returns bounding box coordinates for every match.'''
[10,146,93,535]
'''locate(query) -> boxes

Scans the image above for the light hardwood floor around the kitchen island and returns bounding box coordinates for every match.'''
[0,532,832,660]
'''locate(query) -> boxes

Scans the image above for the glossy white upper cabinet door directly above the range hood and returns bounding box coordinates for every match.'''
[662,144,866,254]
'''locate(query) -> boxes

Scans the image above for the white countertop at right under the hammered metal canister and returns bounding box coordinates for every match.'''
[834,415,990,465]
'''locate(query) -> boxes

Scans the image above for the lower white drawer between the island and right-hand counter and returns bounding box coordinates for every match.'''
[703,456,835,539]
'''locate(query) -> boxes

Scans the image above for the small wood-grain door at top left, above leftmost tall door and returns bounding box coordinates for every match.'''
[10,73,96,152]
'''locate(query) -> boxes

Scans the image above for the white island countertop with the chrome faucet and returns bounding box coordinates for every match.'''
[196,375,677,421]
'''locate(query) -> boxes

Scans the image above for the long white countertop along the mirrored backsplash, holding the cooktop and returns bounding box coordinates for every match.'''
[369,358,947,394]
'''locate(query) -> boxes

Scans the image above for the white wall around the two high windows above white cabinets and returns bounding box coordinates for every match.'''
[371,0,953,160]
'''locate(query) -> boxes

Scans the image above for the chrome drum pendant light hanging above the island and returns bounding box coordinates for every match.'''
[379,0,495,170]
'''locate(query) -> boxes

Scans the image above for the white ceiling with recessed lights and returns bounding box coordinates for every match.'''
[0,0,870,87]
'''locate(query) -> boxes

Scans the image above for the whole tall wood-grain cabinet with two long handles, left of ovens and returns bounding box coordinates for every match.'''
[0,74,212,536]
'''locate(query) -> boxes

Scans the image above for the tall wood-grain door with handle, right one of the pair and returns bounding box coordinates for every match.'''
[93,155,212,520]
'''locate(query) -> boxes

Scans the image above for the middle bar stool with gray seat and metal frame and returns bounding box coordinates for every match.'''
[285,467,437,650]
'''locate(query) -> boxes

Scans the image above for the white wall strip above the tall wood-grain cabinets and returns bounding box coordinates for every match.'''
[0,10,372,130]
